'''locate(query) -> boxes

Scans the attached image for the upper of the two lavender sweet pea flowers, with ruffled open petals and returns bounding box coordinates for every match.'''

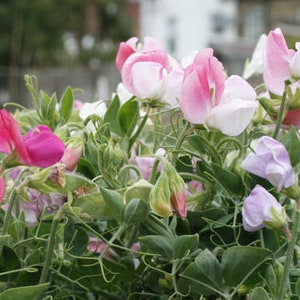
[241,136,296,191]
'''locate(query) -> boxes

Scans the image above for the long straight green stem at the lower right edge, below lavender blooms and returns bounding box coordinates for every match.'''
[277,200,300,300]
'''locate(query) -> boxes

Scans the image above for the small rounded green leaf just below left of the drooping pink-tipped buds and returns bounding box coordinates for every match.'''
[124,198,149,224]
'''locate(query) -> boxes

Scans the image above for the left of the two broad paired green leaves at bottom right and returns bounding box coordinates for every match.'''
[178,249,222,297]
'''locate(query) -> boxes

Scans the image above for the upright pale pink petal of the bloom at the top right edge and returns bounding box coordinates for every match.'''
[263,28,298,95]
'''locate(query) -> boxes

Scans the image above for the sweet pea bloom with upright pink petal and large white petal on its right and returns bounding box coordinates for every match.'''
[179,49,258,136]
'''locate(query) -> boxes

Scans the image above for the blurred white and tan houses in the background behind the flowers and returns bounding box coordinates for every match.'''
[131,0,300,74]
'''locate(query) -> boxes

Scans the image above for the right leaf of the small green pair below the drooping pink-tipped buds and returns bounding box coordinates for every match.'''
[174,234,199,258]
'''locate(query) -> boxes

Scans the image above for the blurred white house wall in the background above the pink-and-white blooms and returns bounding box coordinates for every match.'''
[140,0,236,59]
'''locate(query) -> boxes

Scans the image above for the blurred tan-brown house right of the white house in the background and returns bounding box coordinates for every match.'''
[212,0,300,74]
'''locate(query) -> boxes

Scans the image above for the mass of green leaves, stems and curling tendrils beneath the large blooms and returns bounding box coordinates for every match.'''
[0,59,300,300]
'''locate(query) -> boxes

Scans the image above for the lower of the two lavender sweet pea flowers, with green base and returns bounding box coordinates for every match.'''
[242,185,287,231]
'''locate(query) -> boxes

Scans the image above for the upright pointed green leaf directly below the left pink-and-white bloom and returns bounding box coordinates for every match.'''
[118,98,139,137]
